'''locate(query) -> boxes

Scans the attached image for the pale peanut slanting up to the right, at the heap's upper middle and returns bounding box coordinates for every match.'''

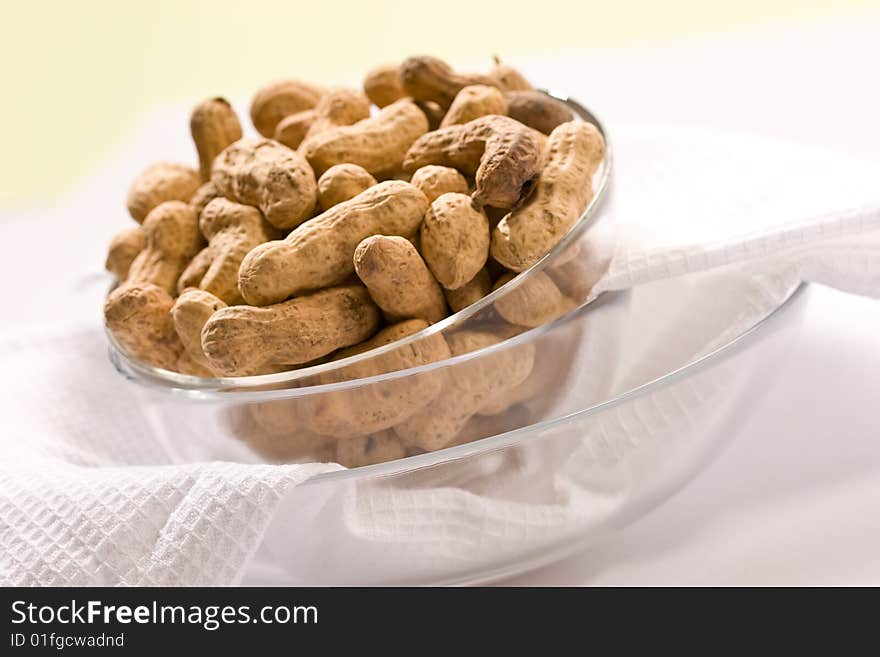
[300,98,428,178]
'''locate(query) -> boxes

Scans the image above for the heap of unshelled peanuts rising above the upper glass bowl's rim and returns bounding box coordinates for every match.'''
[104,57,604,390]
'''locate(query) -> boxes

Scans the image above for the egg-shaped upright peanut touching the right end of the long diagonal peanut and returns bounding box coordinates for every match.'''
[421,193,489,290]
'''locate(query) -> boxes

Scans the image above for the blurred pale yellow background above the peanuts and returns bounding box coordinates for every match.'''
[0,0,880,208]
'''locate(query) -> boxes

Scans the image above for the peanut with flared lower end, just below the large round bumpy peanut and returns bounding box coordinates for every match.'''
[178,198,278,305]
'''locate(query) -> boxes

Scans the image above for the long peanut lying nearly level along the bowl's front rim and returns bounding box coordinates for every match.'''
[202,285,379,376]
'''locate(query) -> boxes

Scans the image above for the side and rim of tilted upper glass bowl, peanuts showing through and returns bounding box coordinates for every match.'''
[108,94,614,467]
